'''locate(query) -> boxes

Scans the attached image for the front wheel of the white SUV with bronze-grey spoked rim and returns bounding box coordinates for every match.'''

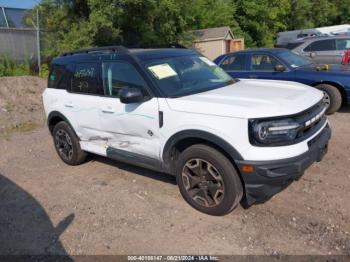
[176,144,243,216]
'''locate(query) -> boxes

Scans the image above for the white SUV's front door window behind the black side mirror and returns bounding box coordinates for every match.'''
[102,62,145,97]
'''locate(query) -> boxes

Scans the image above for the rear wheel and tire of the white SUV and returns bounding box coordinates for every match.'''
[52,121,87,166]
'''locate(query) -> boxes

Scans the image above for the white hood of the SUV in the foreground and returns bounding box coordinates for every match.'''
[167,79,323,118]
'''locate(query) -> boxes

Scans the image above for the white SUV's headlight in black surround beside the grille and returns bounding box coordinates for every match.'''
[249,118,300,146]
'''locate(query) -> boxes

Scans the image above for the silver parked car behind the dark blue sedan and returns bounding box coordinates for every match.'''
[287,36,350,64]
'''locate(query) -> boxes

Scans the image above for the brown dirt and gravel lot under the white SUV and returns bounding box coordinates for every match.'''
[0,79,350,255]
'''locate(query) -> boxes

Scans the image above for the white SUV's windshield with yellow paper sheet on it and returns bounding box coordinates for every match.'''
[146,56,235,97]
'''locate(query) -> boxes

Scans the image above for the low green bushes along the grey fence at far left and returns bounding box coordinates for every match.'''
[0,56,32,77]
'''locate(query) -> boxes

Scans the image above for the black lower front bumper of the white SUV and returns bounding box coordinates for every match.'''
[236,125,331,207]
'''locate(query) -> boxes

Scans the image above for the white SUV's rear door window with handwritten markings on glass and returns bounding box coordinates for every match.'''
[71,63,103,95]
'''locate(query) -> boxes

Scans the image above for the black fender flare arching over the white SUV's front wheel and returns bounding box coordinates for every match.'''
[162,129,244,162]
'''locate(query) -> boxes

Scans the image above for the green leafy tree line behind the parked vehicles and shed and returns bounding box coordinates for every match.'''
[27,0,350,58]
